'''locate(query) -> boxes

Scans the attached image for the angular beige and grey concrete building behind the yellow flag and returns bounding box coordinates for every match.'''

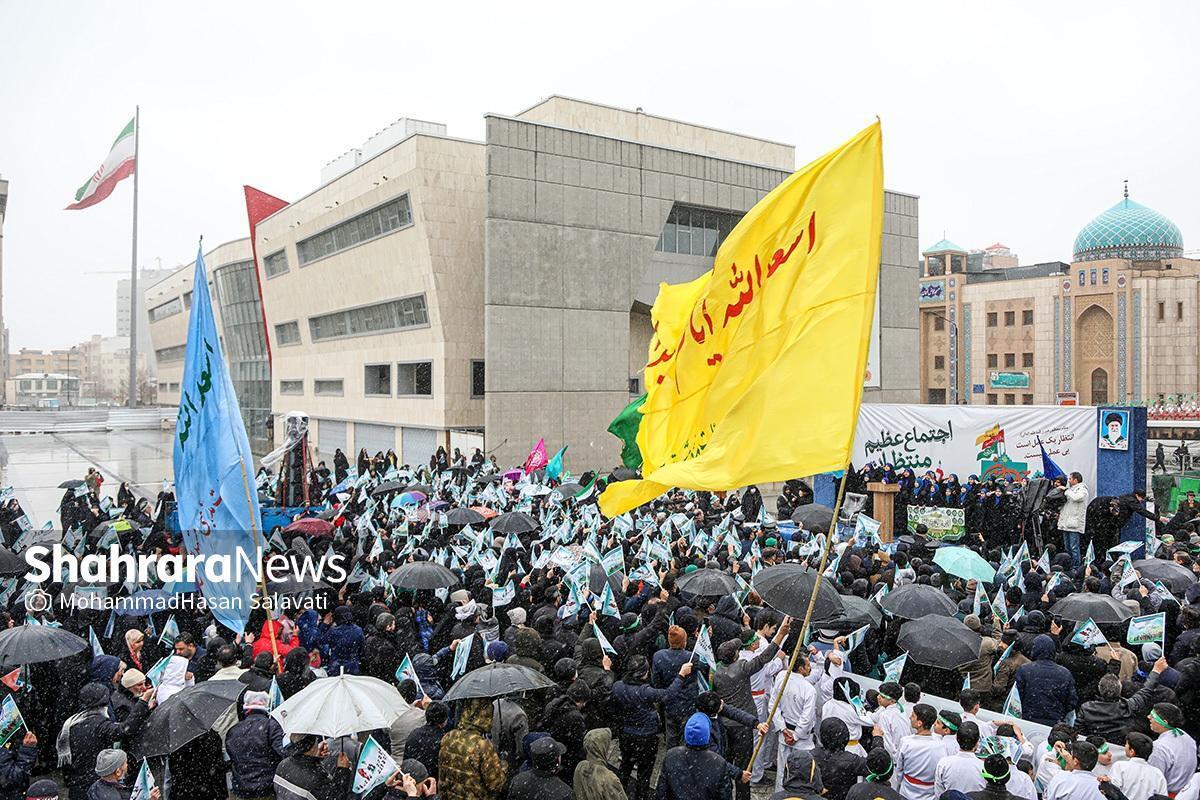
[146,97,919,473]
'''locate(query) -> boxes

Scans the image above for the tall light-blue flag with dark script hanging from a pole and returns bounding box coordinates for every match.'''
[174,252,259,633]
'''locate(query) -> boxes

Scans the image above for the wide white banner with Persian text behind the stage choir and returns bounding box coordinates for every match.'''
[853,403,1097,494]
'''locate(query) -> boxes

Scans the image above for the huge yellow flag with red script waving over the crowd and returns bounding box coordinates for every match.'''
[600,122,883,516]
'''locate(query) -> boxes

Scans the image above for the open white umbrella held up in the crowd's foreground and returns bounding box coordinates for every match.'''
[271,674,409,736]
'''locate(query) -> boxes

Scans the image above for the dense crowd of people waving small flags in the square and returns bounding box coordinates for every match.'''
[0,451,1200,800]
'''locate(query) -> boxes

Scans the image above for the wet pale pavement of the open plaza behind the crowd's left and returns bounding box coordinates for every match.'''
[0,431,172,528]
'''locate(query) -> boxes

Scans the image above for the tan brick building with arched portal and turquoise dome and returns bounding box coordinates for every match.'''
[918,191,1200,405]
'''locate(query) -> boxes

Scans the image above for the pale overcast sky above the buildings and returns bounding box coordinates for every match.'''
[0,0,1200,350]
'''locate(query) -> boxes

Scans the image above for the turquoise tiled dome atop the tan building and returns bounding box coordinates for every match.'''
[1074,196,1183,261]
